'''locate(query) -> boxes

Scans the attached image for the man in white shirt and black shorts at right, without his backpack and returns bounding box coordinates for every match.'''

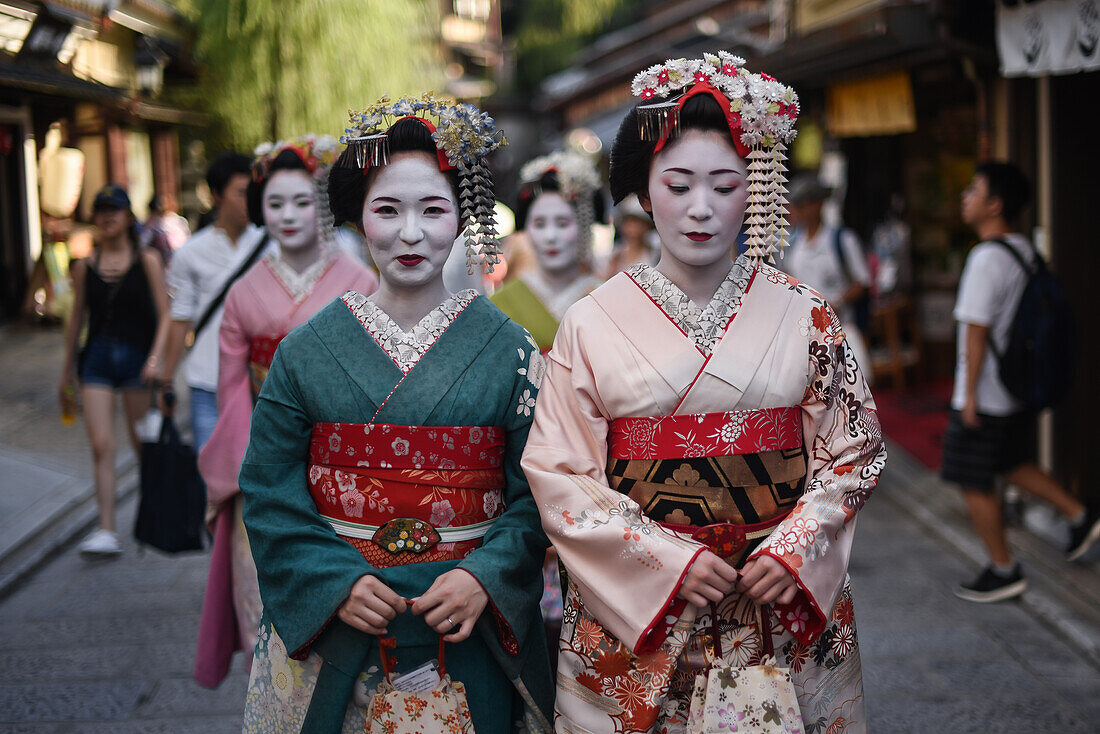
[941,163,1100,602]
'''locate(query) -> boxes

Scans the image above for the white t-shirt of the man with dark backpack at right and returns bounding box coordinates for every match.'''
[952,234,1035,416]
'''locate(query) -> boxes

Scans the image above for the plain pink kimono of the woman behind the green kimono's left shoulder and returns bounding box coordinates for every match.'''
[195,251,378,688]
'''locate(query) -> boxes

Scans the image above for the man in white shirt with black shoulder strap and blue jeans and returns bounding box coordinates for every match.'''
[161,153,263,451]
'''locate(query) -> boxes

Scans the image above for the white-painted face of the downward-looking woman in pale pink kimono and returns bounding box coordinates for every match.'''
[642,130,748,267]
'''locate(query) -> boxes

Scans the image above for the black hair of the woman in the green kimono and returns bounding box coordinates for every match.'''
[329,118,462,227]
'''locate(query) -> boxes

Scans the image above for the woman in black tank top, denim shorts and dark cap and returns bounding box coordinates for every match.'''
[61,184,168,558]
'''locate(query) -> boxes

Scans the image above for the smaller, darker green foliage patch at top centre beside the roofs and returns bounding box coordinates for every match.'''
[516,0,646,89]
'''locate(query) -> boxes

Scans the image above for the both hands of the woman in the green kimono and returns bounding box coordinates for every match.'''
[337,568,488,643]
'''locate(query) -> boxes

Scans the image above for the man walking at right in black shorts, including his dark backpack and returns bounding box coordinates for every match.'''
[942,163,1100,602]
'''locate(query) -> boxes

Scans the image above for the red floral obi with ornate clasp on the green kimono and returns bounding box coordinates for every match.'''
[309,423,505,568]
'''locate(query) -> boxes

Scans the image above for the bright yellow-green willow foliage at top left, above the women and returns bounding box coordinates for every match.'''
[176,0,443,150]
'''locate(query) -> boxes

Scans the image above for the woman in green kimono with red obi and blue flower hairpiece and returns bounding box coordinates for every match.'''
[240,97,553,734]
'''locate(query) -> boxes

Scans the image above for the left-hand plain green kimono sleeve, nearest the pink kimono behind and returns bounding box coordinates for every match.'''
[239,330,373,659]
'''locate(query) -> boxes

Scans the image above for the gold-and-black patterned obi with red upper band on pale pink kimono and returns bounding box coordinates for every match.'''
[607,407,806,566]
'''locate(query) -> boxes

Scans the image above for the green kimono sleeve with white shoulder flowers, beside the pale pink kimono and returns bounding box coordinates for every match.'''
[459,330,550,655]
